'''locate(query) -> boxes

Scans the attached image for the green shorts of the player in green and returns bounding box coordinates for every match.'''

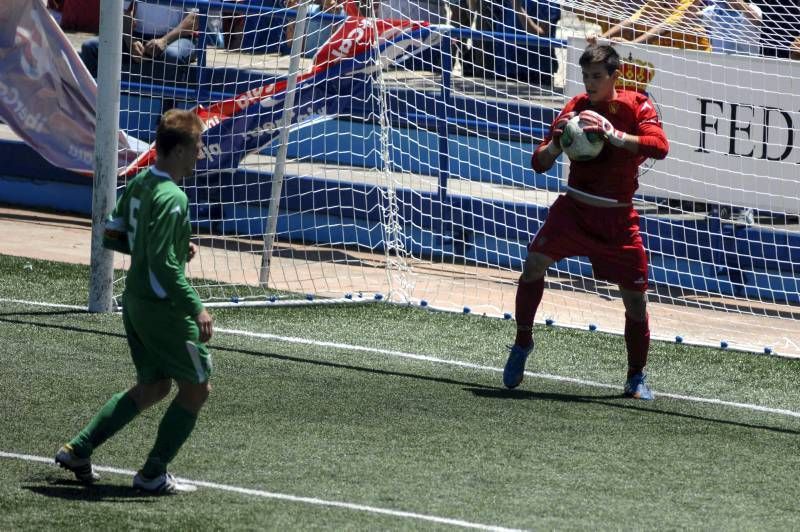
[122,296,212,384]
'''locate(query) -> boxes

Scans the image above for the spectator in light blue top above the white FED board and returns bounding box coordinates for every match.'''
[703,0,762,55]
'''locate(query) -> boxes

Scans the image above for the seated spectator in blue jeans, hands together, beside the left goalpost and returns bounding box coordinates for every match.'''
[81,0,197,77]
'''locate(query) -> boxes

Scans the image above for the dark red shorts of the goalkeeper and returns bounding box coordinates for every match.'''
[528,196,647,292]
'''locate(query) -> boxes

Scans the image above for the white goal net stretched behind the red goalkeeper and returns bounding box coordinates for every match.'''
[106,0,800,355]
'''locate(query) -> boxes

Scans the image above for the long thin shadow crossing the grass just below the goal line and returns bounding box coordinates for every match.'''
[0,311,800,435]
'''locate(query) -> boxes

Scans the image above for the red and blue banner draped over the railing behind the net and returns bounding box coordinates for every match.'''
[123,10,439,176]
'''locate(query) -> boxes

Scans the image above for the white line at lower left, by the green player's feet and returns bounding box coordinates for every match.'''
[0,451,517,532]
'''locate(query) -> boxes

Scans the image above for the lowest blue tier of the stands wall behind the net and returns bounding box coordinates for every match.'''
[0,137,800,304]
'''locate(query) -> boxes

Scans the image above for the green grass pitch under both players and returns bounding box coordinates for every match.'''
[0,256,800,530]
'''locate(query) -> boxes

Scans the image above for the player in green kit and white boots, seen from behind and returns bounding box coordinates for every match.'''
[55,110,213,494]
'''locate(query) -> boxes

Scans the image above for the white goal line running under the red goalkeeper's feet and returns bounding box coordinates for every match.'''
[0,298,800,419]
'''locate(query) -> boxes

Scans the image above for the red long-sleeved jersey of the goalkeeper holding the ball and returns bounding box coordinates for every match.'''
[533,89,669,203]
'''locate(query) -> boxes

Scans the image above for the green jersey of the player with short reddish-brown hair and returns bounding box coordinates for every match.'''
[107,167,203,317]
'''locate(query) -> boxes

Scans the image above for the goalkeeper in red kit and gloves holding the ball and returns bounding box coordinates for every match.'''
[503,45,669,400]
